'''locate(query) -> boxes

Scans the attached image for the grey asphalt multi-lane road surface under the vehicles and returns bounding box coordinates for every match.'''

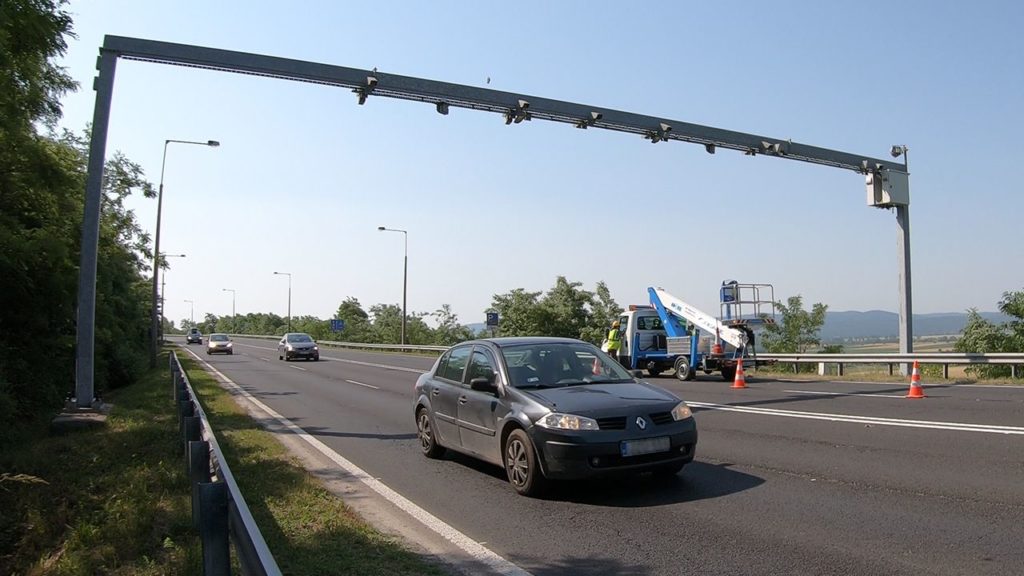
[182,339,1024,576]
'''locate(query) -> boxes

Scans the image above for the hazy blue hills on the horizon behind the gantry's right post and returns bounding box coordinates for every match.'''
[821,310,1010,342]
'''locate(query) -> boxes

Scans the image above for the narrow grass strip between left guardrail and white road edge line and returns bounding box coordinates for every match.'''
[178,354,444,576]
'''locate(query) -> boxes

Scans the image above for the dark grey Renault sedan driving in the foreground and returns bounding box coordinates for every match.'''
[414,337,697,495]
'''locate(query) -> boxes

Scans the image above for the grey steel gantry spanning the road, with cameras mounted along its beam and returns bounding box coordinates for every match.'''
[77,36,910,406]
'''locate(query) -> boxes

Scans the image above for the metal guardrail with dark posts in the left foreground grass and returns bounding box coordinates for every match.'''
[169,352,281,576]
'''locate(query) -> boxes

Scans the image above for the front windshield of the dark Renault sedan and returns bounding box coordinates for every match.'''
[502,342,633,388]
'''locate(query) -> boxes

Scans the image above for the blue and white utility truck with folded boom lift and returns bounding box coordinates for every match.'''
[606,280,775,380]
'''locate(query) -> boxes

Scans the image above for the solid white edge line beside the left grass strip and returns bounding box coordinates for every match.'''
[179,348,531,576]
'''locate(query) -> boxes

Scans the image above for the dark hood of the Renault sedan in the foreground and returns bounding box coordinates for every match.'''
[522,382,679,414]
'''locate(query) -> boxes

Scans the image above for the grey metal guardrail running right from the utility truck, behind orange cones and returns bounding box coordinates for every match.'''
[758,353,1024,378]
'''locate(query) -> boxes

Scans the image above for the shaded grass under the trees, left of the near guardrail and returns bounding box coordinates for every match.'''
[0,348,202,575]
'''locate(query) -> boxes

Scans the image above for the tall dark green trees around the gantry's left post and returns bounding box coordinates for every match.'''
[0,0,153,443]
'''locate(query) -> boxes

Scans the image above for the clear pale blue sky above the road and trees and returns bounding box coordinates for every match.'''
[62,0,1024,323]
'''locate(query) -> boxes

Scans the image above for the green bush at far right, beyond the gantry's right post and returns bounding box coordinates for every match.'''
[953,290,1024,378]
